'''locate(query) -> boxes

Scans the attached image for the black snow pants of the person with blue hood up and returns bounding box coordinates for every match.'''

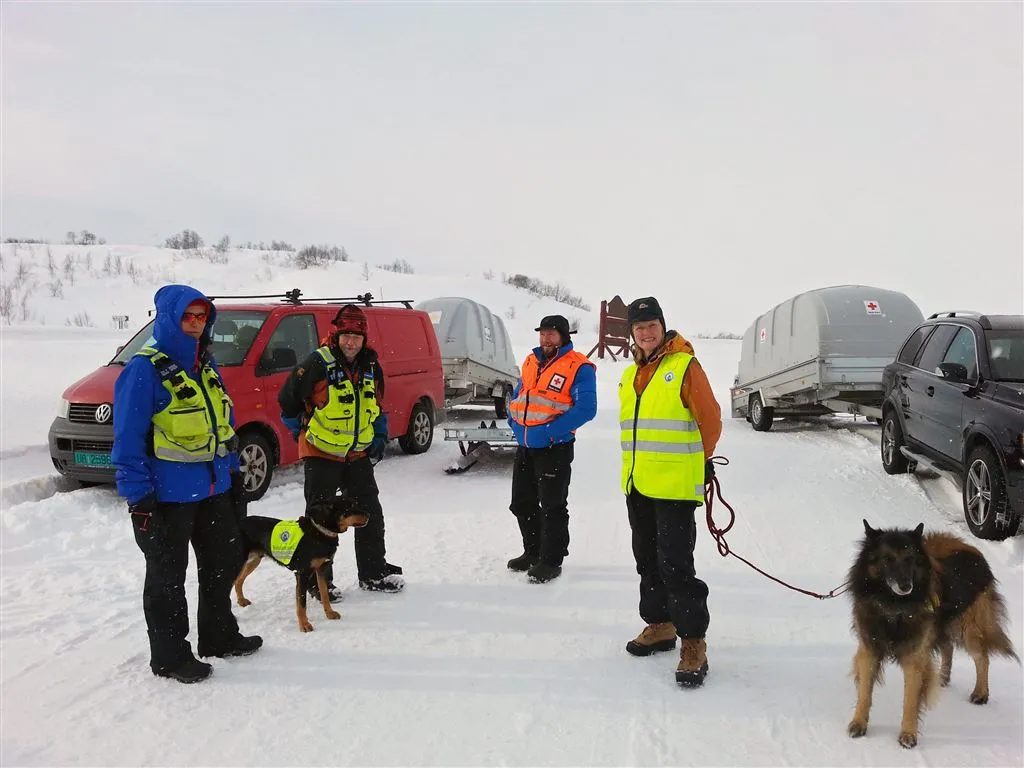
[132,493,244,673]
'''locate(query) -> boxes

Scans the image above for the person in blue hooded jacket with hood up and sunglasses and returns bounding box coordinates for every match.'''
[111,285,263,683]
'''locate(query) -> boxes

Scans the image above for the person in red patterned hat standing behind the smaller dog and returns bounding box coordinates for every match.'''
[278,304,406,602]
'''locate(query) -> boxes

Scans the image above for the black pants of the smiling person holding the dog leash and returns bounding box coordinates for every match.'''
[626,488,711,639]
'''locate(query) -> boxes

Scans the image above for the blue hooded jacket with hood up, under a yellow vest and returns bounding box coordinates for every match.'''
[111,286,239,504]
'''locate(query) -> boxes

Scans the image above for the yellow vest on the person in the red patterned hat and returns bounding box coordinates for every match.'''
[306,347,381,456]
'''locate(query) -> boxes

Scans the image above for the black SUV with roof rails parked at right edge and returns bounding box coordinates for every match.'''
[882,312,1024,540]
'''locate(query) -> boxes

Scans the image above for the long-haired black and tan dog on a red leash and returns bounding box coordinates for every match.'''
[849,520,1020,749]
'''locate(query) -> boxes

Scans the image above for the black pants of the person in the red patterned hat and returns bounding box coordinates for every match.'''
[303,456,386,589]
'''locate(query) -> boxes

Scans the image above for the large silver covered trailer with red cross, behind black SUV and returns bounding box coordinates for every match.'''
[730,286,924,431]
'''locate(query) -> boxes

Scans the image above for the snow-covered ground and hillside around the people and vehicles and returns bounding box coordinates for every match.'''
[0,246,1024,766]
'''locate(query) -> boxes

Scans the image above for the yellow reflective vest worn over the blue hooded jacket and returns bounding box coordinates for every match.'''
[136,347,234,463]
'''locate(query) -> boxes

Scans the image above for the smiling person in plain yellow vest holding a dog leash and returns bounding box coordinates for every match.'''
[618,297,722,688]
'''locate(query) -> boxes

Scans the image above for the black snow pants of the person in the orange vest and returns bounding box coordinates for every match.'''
[509,440,574,565]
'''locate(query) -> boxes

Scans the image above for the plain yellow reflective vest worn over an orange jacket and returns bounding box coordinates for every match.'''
[618,352,705,502]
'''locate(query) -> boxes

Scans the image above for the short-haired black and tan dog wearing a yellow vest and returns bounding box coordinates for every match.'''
[234,497,367,632]
